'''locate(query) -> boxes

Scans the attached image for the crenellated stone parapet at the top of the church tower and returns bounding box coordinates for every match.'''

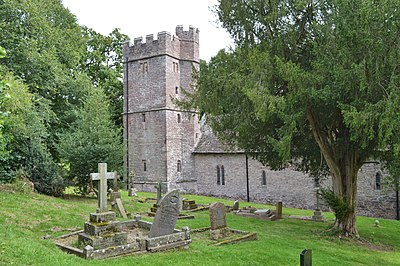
[123,26,199,62]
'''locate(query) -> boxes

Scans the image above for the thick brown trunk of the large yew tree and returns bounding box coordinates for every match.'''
[307,108,362,237]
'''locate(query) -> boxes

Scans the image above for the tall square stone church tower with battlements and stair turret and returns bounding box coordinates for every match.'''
[123,26,200,191]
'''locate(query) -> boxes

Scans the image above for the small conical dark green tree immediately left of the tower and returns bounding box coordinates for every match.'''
[57,88,123,194]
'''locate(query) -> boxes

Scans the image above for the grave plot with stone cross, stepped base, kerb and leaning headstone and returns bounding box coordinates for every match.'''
[55,164,192,259]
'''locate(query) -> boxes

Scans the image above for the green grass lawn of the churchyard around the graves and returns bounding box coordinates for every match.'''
[0,187,400,266]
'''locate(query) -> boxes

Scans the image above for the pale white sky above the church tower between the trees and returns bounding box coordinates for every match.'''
[62,0,233,61]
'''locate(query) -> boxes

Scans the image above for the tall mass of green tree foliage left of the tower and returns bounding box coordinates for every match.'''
[0,0,125,195]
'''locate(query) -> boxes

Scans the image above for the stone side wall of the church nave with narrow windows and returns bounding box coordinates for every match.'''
[195,154,396,219]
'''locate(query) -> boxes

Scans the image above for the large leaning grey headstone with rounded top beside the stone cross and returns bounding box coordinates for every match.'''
[149,190,180,237]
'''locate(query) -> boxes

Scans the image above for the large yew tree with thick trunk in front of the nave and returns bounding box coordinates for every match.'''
[191,0,400,236]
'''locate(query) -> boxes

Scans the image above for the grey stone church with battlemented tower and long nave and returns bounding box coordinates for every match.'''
[123,26,399,219]
